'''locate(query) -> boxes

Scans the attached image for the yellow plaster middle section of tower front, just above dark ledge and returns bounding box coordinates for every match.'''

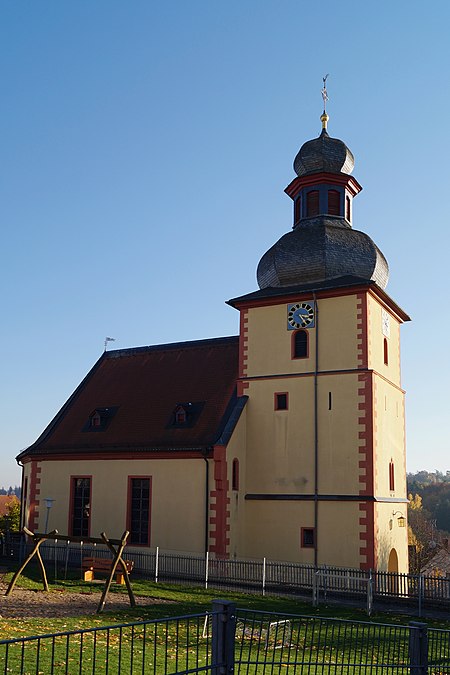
[243,373,360,494]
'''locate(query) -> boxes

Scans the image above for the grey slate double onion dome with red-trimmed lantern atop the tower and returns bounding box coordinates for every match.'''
[257,111,389,289]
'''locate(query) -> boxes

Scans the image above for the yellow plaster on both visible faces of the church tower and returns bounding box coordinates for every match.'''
[244,295,407,570]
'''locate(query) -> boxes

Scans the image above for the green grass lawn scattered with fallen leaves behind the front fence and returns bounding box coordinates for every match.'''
[0,569,450,675]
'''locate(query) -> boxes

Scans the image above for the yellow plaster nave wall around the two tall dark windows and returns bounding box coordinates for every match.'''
[29,459,205,553]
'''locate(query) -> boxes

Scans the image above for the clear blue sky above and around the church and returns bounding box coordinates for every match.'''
[0,0,450,486]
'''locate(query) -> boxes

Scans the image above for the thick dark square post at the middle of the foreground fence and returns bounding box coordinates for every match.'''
[211,600,236,675]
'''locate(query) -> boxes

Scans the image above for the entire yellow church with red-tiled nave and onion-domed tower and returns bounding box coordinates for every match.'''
[17,111,409,572]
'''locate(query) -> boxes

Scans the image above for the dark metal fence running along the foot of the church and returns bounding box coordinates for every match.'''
[18,541,450,616]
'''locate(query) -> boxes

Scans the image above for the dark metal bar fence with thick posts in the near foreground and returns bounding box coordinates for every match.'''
[0,601,450,675]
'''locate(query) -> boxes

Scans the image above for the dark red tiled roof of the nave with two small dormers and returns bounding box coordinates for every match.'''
[18,337,238,459]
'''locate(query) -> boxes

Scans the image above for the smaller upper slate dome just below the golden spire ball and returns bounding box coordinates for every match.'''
[294,129,355,176]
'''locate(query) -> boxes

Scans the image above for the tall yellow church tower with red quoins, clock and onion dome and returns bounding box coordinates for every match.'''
[229,111,409,572]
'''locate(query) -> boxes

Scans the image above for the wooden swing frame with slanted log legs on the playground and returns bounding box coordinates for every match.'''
[5,527,136,614]
